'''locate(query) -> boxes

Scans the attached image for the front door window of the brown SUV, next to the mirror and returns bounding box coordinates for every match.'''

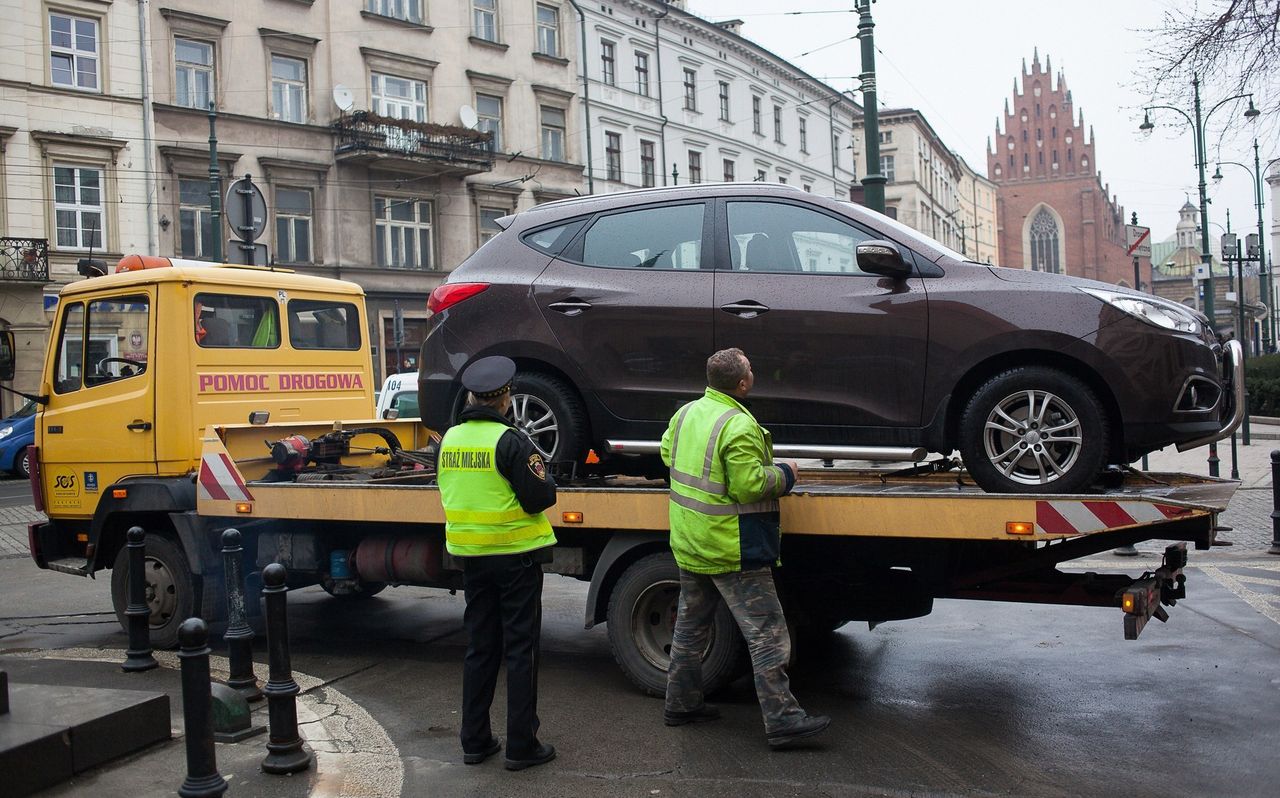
[728,202,873,274]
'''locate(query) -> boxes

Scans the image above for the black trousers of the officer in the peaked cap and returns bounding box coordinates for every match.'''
[461,553,543,760]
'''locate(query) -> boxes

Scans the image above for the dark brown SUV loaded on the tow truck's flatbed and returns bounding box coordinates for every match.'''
[419,183,1234,493]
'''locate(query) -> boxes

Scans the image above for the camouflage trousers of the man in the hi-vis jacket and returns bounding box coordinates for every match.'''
[667,567,804,734]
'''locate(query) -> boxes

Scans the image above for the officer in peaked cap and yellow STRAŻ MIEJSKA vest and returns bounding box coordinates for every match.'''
[436,356,556,770]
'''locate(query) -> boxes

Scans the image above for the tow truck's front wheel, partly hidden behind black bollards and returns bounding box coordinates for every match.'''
[111,534,198,648]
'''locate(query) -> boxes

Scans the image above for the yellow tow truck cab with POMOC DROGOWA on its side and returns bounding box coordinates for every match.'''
[17,255,374,574]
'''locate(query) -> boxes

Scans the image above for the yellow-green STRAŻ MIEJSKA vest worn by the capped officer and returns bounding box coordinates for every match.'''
[436,420,556,557]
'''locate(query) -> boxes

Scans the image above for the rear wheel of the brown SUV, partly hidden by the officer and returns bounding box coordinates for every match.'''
[511,371,586,462]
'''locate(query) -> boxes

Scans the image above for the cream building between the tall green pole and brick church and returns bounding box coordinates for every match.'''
[854,108,1000,264]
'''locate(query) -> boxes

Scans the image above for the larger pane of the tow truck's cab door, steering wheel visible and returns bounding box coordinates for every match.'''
[81,295,151,388]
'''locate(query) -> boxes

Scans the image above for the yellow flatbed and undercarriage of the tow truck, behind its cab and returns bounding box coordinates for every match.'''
[196,421,1238,694]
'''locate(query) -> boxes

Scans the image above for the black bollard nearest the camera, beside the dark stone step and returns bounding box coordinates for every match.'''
[178,617,227,798]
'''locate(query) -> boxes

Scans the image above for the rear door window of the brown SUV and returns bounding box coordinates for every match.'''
[581,202,707,270]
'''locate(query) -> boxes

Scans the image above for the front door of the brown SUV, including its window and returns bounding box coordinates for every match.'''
[714,197,928,443]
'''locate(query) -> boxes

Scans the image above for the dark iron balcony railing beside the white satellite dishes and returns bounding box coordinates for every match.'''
[333,111,493,170]
